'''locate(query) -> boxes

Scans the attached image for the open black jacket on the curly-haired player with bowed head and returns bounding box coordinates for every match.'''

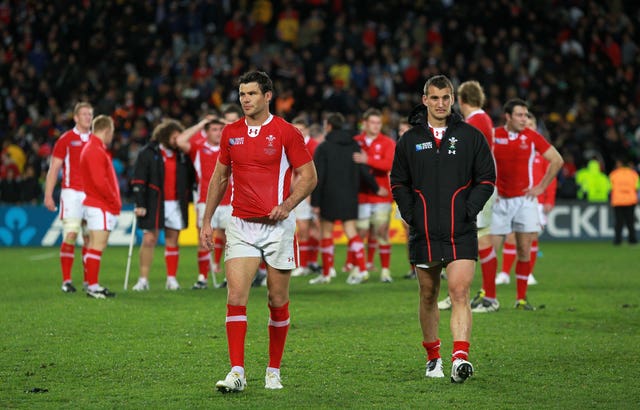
[131,141,195,229]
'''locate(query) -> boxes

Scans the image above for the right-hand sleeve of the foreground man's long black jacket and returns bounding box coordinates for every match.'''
[467,128,496,219]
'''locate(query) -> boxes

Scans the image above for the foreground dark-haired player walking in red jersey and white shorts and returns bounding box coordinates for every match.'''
[200,71,317,393]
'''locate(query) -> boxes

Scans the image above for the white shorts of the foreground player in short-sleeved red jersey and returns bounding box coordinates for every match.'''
[224,213,298,270]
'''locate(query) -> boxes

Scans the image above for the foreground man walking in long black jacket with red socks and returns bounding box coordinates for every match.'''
[391,75,496,383]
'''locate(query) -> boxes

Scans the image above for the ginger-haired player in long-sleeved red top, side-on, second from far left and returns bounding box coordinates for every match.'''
[80,115,122,299]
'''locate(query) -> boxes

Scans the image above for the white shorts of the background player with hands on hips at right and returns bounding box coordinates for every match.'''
[491,196,541,235]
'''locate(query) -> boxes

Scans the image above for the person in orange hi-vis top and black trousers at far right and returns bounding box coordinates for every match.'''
[609,159,640,245]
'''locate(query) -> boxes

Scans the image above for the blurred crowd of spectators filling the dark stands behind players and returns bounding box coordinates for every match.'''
[0,0,640,203]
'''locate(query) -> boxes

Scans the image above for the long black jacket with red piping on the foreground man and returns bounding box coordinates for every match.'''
[391,105,496,265]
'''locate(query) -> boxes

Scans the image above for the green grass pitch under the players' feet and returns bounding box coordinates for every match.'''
[0,243,640,409]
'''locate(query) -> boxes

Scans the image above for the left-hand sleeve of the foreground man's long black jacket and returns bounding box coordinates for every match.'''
[390,135,414,225]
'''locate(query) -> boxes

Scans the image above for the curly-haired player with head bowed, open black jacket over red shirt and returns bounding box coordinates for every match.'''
[131,120,194,291]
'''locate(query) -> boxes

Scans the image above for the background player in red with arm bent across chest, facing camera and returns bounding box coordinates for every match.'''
[353,108,396,283]
